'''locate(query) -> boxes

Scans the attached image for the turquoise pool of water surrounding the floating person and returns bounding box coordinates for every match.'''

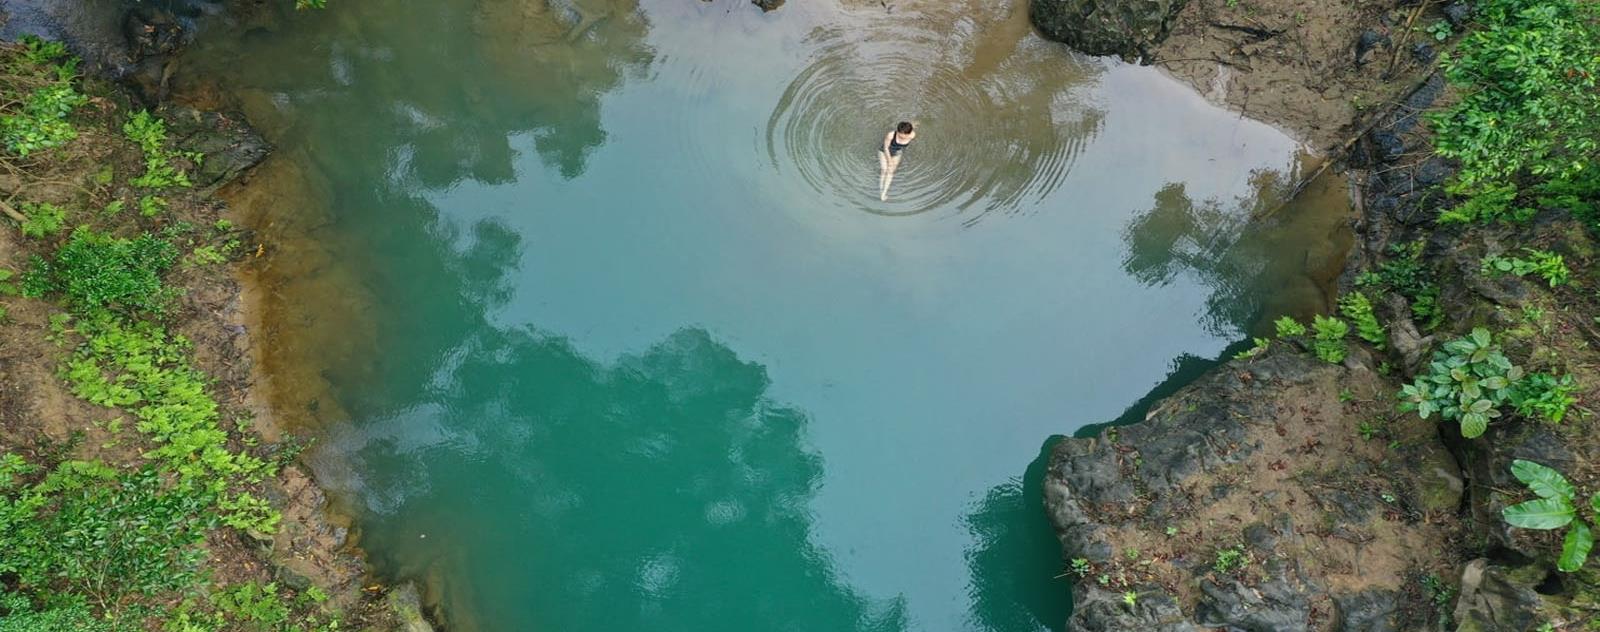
[190,0,1349,630]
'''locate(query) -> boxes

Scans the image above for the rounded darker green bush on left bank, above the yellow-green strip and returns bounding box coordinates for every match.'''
[22,227,178,315]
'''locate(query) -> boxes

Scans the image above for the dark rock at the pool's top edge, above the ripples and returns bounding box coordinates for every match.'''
[1029,0,1189,59]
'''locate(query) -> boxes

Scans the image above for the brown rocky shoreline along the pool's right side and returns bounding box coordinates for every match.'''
[1034,0,1600,632]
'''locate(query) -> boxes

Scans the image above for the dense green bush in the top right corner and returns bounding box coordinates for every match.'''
[1432,0,1600,222]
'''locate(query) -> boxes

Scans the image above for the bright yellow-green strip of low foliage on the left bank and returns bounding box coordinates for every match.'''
[62,312,278,533]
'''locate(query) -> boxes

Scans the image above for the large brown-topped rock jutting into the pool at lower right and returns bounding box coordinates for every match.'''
[1045,352,1462,632]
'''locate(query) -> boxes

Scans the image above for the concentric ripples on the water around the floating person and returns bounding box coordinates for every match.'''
[766,16,1101,224]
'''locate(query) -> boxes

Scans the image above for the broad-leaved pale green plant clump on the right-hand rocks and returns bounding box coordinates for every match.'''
[1398,326,1523,438]
